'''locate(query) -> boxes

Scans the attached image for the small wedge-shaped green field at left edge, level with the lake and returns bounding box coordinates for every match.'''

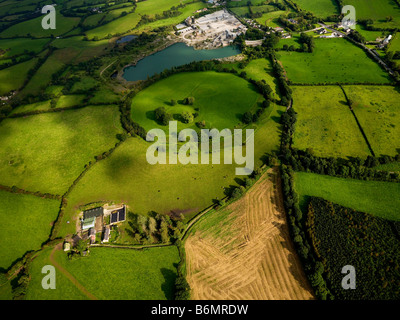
[0,59,37,95]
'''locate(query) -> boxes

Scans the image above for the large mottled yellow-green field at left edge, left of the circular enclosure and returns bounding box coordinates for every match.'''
[0,106,122,194]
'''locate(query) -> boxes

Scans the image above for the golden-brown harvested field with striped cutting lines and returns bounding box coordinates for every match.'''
[185,168,313,300]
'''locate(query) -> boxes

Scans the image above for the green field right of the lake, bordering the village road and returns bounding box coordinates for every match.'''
[279,39,390,83]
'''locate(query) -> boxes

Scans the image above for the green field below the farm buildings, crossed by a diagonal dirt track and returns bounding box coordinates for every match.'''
[26,246,180,300]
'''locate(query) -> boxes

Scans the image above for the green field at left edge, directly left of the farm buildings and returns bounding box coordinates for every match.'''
[0,190,60,269]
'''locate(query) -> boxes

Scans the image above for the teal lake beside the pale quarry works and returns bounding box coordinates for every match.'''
[124,43,240,81]
